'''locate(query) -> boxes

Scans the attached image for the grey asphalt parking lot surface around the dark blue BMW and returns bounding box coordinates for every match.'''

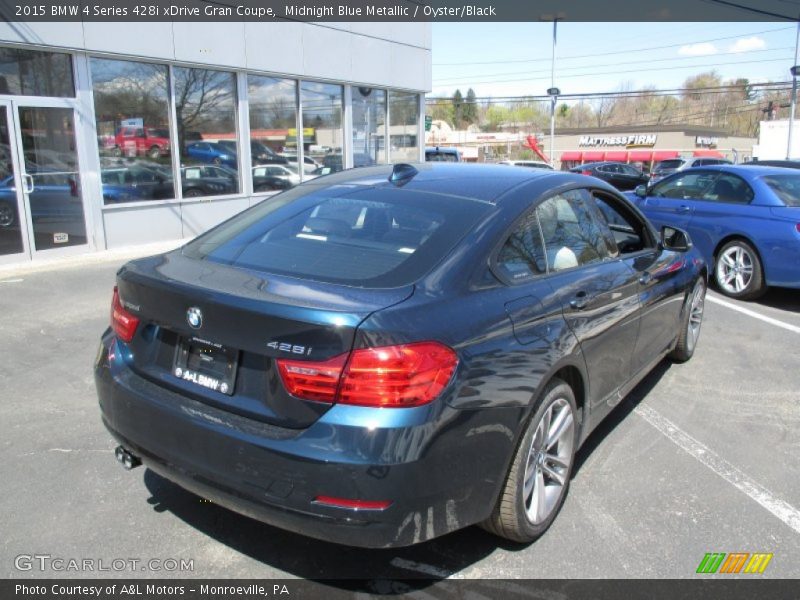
[0,251,800,579]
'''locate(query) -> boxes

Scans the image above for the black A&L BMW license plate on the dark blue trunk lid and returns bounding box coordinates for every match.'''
[172,337,239,396]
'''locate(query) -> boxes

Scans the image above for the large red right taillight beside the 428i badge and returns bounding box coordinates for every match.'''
[277,342,458,408]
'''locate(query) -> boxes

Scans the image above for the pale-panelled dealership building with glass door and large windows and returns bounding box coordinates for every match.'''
[0,22,431,265]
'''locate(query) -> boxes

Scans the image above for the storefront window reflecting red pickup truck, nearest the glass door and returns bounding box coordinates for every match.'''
[91,58,175,205]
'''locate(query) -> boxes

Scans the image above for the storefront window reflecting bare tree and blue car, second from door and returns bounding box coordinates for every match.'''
[173,67,239,197]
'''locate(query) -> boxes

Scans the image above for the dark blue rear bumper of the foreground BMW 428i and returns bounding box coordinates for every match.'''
[95,334,522,548]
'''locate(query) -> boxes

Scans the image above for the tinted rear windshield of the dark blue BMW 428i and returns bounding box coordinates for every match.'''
[183,186,491,288]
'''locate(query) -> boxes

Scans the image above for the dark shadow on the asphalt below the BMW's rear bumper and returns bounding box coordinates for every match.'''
[144,469,526,593]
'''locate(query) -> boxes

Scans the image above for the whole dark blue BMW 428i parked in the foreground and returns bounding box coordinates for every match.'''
[95,163,707,547]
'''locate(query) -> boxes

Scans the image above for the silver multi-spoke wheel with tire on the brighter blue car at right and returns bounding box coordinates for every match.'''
[714,240,767,300]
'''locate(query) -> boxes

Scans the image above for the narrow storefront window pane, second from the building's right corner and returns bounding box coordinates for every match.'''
[353,87,386,167]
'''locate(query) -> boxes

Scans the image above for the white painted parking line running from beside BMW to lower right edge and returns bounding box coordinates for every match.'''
[633,405,800,533]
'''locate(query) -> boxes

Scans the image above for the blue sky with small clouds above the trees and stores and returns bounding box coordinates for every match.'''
[430,21,797,98]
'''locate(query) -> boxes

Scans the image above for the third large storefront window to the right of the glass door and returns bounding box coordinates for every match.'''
[247,75,298,192]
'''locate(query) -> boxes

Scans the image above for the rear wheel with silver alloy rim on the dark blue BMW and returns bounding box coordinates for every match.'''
[481,378,578,543]
